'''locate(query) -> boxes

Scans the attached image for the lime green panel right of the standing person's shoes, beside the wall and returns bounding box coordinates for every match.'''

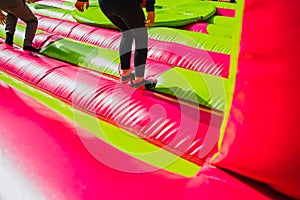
[155,67,228,111]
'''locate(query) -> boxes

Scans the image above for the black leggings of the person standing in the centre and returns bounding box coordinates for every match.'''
[98,0,148,77]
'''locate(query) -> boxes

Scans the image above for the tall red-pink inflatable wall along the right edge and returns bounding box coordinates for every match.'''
[214,0,300,199]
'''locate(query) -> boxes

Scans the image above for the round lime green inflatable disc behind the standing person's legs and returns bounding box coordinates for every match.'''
[73,1,216,28]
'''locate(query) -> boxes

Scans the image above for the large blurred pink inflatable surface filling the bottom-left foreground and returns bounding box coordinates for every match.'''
[0,81,279,200]
